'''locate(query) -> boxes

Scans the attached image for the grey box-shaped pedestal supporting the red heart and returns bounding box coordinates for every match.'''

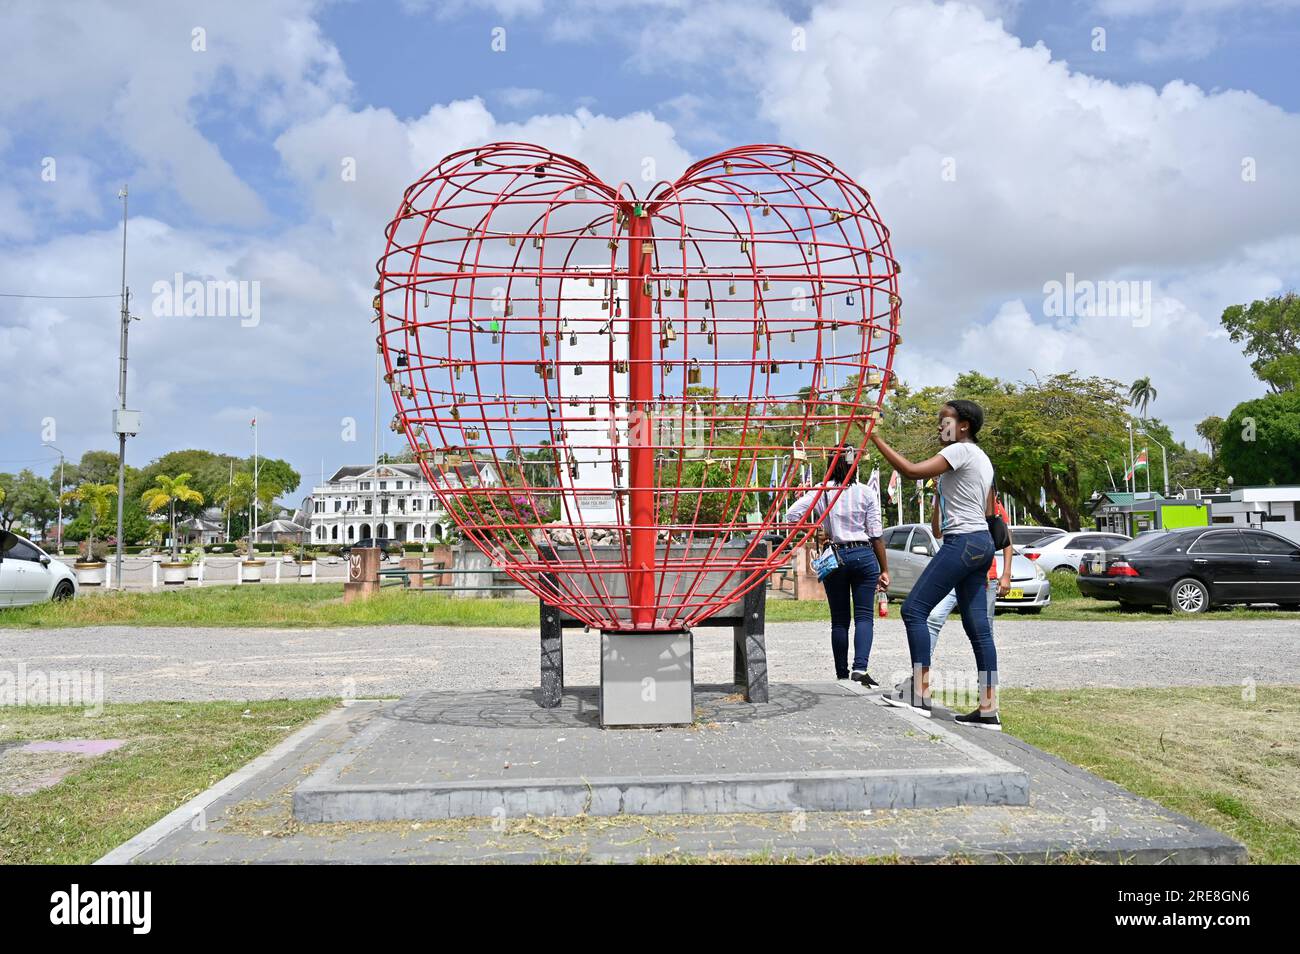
[601,633,696,728]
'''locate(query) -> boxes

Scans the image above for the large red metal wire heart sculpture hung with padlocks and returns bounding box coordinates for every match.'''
[374,143,900,632]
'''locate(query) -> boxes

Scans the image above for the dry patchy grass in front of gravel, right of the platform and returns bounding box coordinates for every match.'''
[1002,686,1300,864]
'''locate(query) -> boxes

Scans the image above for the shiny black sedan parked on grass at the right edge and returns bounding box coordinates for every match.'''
[1079,526,1300,612]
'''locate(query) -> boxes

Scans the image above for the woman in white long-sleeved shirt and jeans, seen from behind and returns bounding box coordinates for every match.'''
[785,447,889,689]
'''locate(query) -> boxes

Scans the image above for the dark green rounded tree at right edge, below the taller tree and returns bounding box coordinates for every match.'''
[1219,390,1300,486]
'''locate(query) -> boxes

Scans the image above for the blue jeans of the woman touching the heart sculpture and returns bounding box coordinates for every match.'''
[902,530,997,691]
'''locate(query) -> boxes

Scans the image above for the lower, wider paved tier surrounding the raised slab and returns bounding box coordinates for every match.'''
[101,684,1245,864]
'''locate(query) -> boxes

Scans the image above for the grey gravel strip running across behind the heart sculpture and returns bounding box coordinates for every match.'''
[0,620,1300,702]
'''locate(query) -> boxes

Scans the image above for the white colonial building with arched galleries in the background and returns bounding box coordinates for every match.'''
[308,460,497,546]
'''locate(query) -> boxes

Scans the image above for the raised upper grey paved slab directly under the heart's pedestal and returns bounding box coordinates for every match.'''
[294,682,1028,821]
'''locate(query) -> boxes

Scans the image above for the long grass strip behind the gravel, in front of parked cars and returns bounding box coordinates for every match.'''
[0,578,1300,629]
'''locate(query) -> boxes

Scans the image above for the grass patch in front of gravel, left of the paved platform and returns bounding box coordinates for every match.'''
[0,699,338,864]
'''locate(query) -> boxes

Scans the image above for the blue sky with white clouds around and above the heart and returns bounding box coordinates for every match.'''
[0,0,1300,501]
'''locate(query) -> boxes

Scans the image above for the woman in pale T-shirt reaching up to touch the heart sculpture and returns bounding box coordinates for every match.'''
[871,400,1002,730]
